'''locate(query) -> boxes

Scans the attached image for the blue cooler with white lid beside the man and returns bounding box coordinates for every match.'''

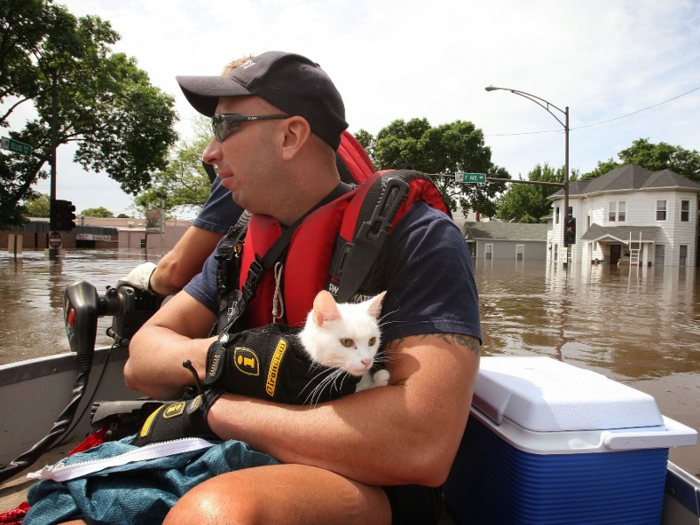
[443,357,697,525]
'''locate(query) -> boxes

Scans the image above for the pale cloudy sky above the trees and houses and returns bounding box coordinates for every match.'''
[2,0,700,214]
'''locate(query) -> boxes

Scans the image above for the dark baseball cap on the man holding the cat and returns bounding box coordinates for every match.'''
[176,51,348,150]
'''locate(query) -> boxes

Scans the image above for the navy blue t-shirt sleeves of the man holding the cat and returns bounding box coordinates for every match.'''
[185,202,482,341]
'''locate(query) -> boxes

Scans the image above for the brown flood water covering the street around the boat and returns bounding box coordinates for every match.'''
[0,250,700,477]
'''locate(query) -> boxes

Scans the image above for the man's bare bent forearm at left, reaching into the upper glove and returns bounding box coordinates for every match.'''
[124,292,216,399]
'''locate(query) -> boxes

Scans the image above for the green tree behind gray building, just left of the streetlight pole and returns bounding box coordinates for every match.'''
[498,162,578,223]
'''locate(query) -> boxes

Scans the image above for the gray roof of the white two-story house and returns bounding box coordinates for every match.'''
[549,164,700,200]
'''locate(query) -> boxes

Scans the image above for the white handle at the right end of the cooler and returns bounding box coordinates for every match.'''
[602,416,698,450]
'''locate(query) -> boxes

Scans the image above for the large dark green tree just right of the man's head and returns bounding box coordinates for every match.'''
[355,118,510,217]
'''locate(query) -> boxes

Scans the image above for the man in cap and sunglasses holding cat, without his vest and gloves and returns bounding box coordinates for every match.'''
[125,52,481,525]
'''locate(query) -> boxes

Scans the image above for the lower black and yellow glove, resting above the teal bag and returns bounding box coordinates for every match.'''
[131,387,223,447]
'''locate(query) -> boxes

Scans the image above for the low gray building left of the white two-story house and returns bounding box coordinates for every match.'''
[462,221,547,261]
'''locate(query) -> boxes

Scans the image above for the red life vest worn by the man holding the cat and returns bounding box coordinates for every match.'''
[238,171,449,328]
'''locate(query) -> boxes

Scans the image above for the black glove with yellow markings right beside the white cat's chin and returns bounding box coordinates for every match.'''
[204,324,360,405]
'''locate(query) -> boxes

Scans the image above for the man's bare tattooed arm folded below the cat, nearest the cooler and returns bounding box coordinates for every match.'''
[208,334,479,486]
